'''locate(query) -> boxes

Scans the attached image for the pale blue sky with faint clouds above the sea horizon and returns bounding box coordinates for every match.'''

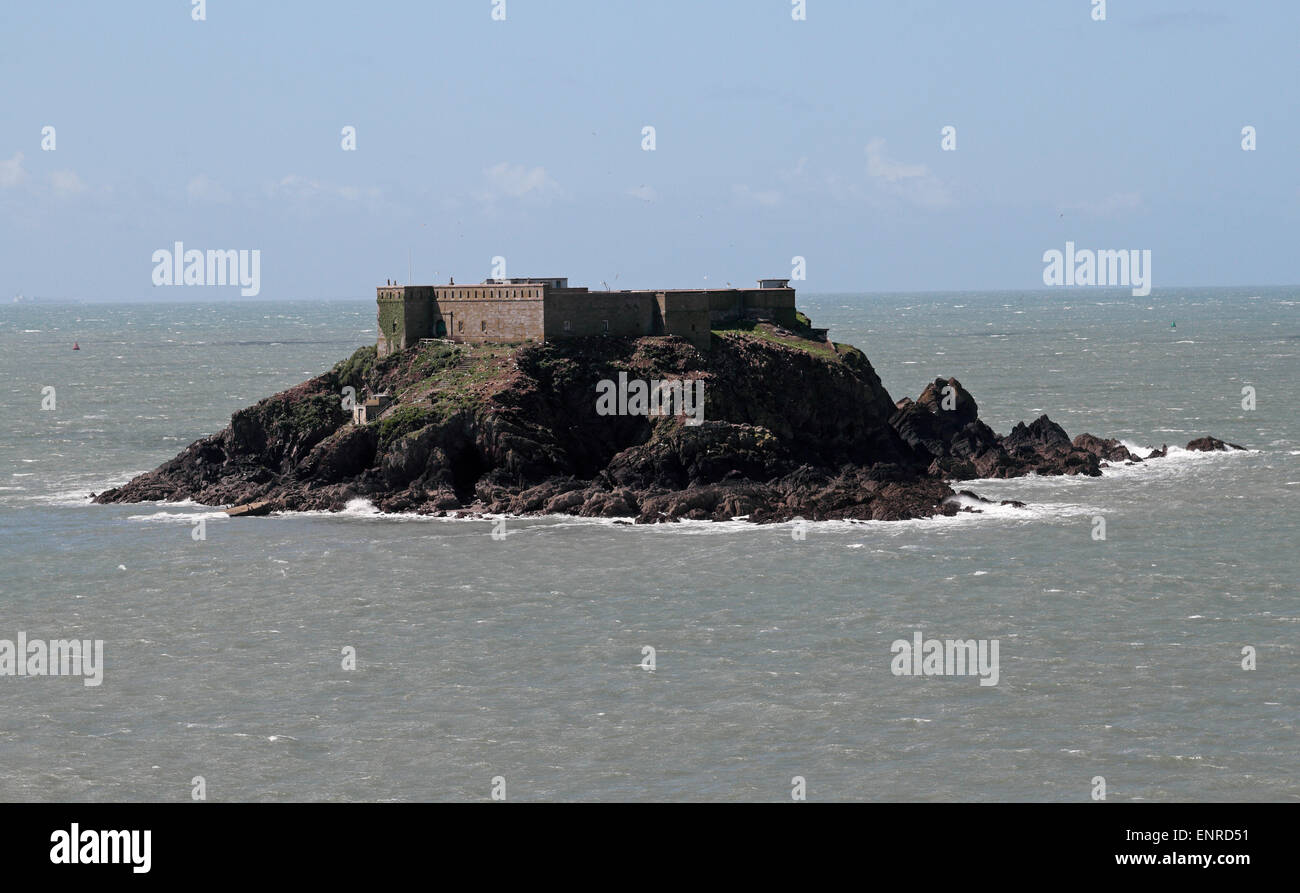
[0,0,1300,300]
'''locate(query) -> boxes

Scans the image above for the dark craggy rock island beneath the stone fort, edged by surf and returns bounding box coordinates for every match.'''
[89,333,1226,523]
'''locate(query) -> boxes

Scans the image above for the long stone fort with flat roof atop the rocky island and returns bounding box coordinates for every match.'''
[378,278,796,356]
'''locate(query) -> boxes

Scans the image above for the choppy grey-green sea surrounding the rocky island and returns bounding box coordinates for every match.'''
[0,289,1300,801]
